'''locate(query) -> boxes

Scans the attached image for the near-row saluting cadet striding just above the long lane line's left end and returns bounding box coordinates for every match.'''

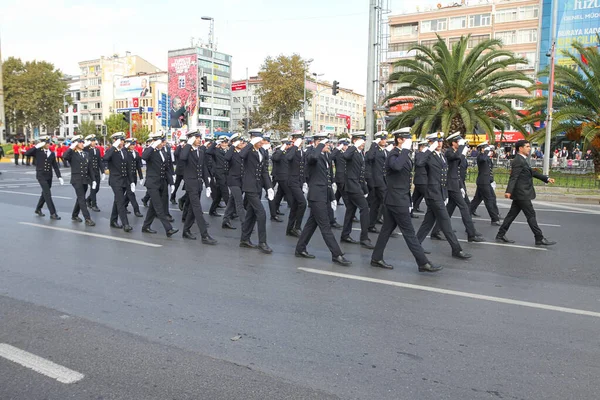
[296,133,352,266]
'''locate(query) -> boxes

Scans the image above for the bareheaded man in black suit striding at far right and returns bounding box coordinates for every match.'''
[496,139,556,246]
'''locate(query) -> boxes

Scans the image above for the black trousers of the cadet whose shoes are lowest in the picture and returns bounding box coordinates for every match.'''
[371,205,429,265]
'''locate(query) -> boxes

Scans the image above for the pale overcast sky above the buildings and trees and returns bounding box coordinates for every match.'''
[0,0,439,94]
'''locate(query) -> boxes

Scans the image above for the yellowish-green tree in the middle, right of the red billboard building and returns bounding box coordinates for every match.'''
[251,54,310,132]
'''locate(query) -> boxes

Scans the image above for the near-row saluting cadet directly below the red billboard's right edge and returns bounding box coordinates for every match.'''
[179,132,217,245]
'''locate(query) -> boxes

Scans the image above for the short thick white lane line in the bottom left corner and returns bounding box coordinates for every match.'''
[0,343,85,384]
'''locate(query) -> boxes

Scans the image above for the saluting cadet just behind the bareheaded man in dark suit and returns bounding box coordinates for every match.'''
[470,141,501,226]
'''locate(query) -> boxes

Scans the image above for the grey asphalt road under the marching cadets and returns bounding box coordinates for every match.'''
[0,164,600,400]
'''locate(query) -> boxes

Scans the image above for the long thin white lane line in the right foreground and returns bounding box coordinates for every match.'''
[298,267,600,318]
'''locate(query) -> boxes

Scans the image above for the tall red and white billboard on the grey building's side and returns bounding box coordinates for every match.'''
[168,54,198,129]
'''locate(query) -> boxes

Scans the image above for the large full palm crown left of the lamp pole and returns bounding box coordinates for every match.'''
[387,35,533,141]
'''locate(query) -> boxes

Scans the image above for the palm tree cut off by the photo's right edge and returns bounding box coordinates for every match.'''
[524,35,600,172]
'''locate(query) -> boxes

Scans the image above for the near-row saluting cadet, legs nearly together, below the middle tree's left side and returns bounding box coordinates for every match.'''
[240,129,275,254]
